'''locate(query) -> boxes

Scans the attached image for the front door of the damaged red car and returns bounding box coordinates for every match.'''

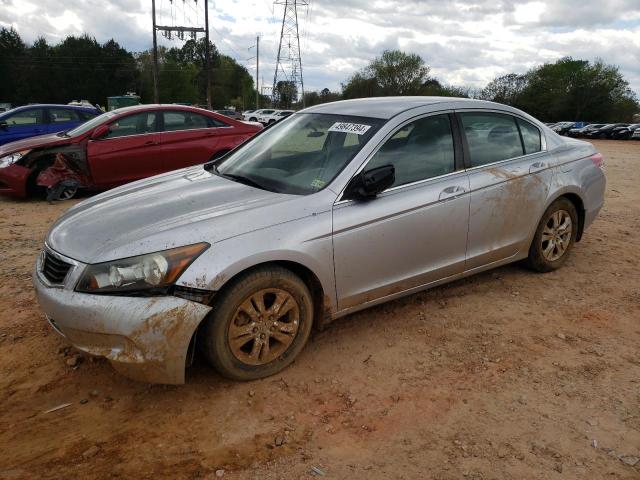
[87,111,166,187]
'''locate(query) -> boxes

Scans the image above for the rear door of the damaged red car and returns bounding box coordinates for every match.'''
[162,110,236,170]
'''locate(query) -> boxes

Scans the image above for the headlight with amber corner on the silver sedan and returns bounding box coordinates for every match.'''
[76,243,210,293]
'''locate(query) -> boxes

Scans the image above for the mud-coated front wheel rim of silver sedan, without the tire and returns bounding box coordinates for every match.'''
[228,288,300,365]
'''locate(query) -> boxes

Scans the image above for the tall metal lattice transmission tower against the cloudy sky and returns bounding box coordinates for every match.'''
[271,0,309,108]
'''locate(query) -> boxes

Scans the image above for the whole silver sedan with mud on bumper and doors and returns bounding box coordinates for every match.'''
[33,97,605,383]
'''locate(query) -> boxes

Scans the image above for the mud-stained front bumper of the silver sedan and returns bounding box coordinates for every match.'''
[33,250,211,384]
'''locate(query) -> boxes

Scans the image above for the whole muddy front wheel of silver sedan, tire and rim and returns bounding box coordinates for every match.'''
[201,266,313,380]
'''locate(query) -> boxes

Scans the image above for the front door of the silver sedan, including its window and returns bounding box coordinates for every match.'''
[333,114,469,310]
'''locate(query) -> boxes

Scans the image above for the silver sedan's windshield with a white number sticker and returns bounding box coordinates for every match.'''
[214,113,384,195]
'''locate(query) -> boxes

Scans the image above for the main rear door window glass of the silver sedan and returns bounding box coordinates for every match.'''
[459,112,524,167]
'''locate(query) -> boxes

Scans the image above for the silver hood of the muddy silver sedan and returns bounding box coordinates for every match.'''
[46,166,305,263]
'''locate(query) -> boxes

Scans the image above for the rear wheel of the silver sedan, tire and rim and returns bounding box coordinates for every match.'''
[525,198,578,272]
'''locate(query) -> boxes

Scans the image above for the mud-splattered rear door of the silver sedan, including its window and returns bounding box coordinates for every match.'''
[457,111,554,270]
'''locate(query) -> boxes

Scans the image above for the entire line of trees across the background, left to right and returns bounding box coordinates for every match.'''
[0,28,640,122]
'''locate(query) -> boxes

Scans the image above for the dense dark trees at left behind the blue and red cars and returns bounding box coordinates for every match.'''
[0,28,260,108]
